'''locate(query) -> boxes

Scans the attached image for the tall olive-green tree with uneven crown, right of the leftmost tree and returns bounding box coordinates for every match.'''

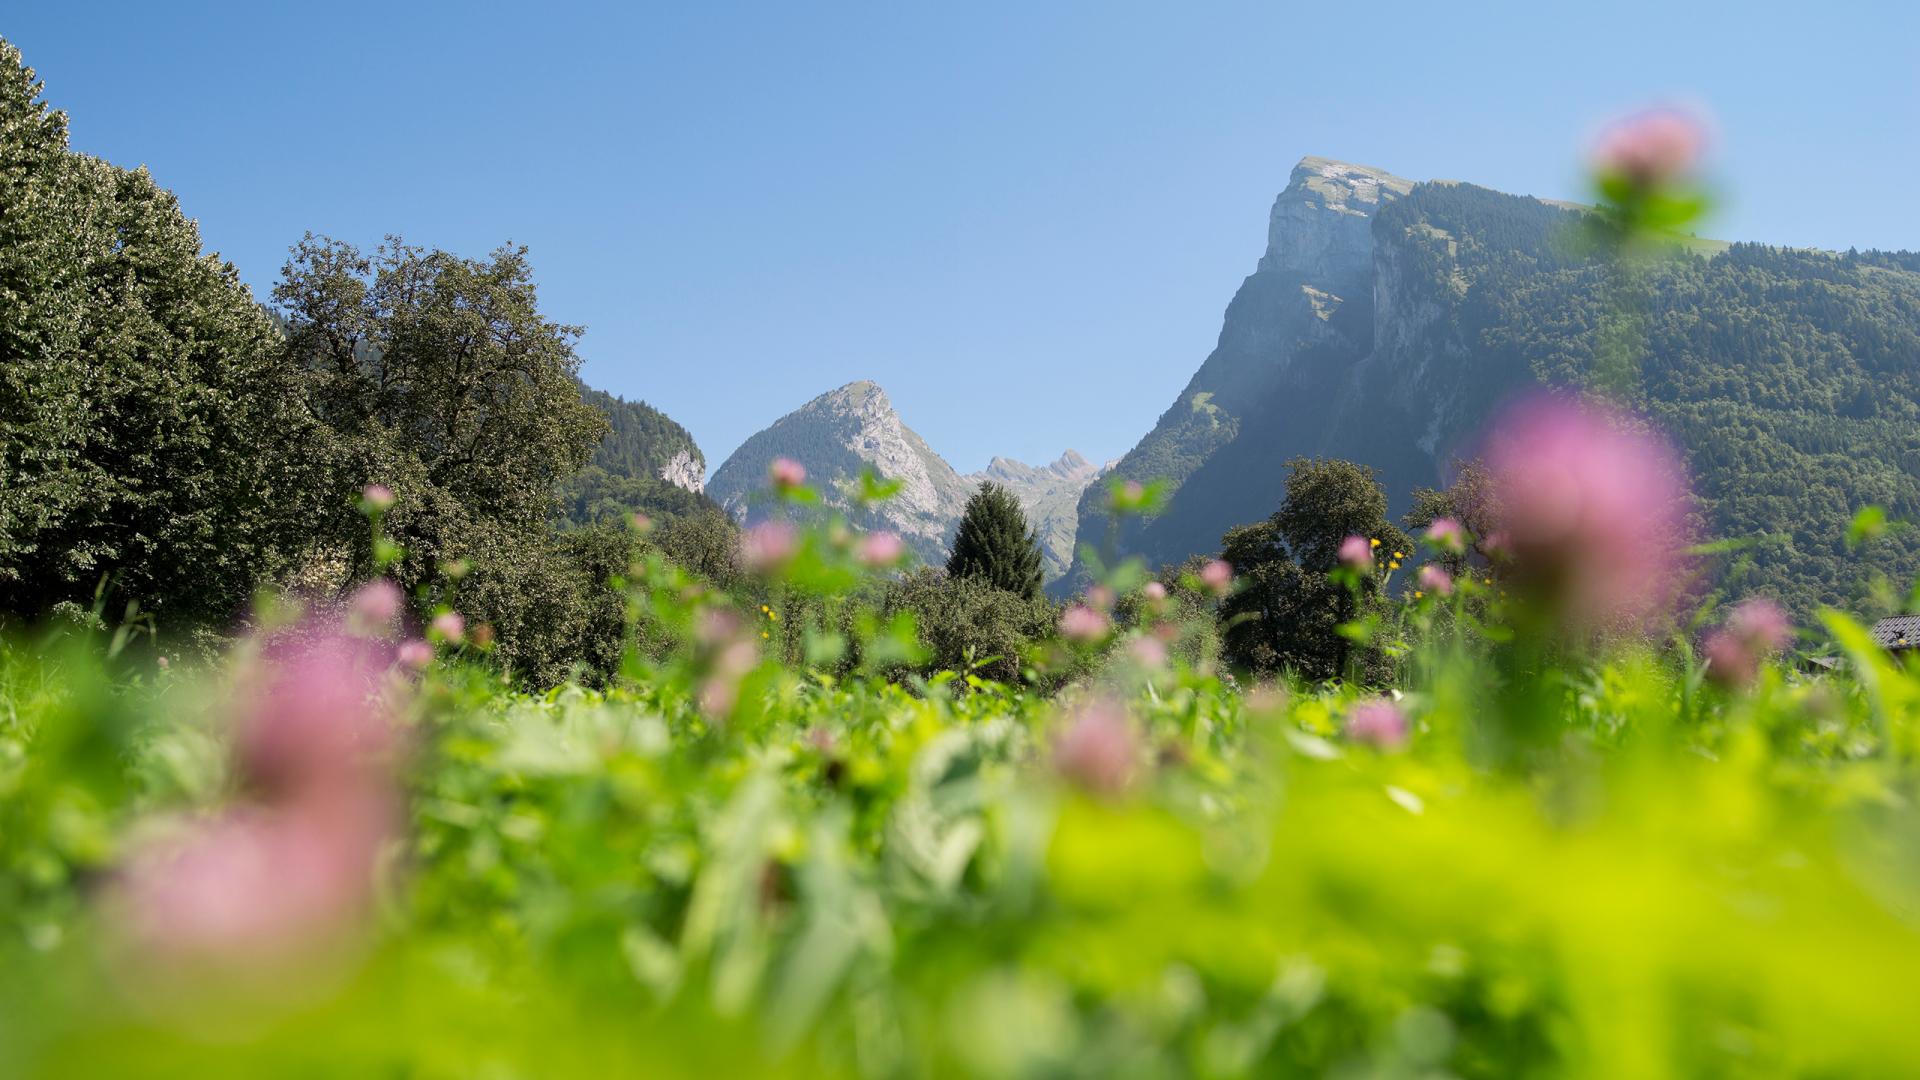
[273,234,609,678]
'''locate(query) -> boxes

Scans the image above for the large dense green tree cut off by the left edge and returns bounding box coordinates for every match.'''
[0,40,313,628]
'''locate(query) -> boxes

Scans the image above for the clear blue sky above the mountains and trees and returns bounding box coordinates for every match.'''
[0,0,1920,471]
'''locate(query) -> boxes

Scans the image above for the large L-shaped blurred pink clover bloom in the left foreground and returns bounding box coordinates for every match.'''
[102,632,399,978]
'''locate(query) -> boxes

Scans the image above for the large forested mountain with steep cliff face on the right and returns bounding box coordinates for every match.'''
[1075,158,1920,611]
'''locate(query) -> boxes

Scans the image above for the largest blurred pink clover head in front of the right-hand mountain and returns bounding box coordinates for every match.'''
[1486,398,1688,628]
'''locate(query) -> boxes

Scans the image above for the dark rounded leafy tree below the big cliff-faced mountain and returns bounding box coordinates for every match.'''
[1219,457,1411,678]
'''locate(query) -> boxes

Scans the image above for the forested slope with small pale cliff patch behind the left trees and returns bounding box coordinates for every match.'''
[561,386,718,527]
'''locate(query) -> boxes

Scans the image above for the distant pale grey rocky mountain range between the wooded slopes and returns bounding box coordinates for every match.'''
[707,380,1100,578]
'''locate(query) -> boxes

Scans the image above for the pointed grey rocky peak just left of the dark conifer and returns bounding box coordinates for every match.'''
[707,380,973,563]
